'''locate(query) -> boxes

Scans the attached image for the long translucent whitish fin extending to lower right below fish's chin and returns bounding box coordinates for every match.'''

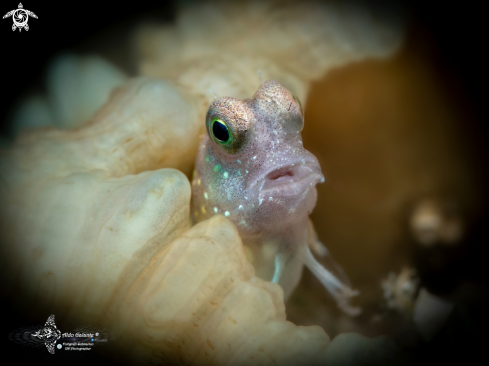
[303,246,362,316]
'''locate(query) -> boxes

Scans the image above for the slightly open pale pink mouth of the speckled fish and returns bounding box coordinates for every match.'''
[258,160,324,196]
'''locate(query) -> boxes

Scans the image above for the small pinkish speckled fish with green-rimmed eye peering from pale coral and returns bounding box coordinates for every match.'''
[191,80,358,314]
